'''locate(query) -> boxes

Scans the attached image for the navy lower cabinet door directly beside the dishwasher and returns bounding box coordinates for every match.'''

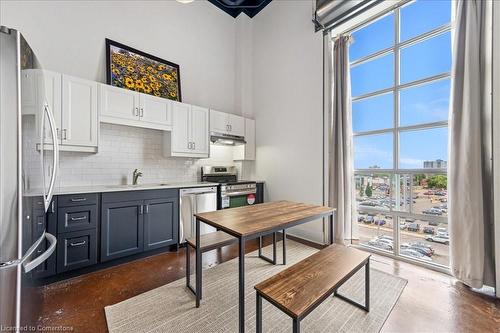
[144,198,179,250]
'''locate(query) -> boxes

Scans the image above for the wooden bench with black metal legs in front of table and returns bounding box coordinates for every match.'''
[255,244,370,333]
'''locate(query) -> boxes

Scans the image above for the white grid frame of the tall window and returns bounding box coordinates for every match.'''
[343,0,455,273]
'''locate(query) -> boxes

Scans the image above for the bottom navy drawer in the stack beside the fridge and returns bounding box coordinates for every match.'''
[57,230,97,273]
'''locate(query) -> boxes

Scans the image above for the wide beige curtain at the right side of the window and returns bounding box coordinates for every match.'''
[448,0,495,288]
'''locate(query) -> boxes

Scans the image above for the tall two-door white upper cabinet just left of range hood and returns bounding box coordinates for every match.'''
[163,102,209,158]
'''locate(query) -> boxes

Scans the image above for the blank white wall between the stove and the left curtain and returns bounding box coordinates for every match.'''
[252,0,323,242]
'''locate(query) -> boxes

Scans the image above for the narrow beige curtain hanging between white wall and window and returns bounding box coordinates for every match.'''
[325,36,355,244]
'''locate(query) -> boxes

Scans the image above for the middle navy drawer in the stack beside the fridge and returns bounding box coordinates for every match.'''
[57,205,98,233]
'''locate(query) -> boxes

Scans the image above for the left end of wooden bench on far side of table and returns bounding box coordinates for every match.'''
[186,231,238,299]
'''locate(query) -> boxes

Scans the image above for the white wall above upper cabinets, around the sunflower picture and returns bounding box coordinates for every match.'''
[0,0,236,112]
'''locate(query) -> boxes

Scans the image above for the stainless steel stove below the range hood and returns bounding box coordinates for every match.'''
[201,166,257,209]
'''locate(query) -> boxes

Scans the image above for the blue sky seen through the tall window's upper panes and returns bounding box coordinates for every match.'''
[349,0,451,169]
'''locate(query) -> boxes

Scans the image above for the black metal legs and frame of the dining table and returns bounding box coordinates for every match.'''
[196,211,334,333]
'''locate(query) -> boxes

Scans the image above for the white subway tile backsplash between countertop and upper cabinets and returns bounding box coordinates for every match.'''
[54,124,234,187]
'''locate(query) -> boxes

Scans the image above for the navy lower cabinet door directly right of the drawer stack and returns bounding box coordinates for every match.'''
[101,200,144,261]
